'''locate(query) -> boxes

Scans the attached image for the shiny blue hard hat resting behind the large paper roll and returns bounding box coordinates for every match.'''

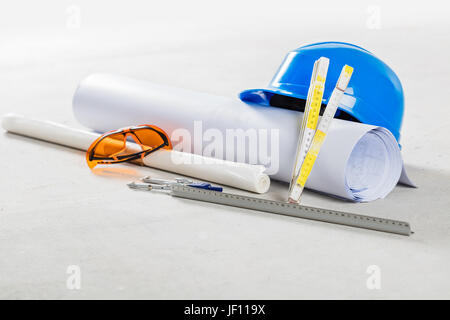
[239,42,404,141]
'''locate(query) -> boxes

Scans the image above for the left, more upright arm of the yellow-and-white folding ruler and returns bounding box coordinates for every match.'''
[289,57,330,197]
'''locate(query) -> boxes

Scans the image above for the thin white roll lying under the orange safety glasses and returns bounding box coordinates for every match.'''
[2,114,270,193]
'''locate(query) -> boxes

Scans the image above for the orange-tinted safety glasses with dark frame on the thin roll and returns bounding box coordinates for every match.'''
[86,124,172,169]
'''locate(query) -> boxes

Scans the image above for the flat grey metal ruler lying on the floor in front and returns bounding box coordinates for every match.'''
[171,184,412,236]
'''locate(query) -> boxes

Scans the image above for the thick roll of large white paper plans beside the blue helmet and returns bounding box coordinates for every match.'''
[73,74,414,201]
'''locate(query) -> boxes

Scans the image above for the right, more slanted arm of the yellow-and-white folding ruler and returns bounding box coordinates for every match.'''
[288,65,353,203]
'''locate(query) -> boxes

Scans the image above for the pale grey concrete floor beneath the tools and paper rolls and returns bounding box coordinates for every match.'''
[0,0,450,299]
